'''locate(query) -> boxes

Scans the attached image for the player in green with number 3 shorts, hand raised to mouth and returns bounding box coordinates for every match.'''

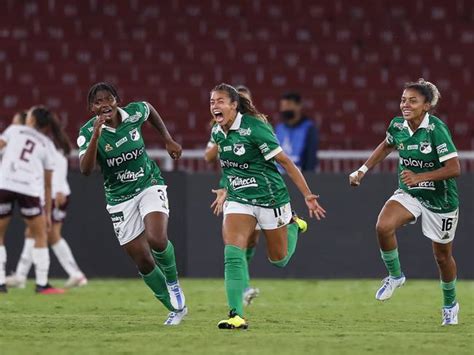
[77,83,187,325]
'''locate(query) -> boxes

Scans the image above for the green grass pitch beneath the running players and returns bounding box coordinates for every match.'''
[0,279,474,355]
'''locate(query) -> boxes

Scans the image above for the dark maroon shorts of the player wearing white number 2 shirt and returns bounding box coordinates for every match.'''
[0,189,43,218]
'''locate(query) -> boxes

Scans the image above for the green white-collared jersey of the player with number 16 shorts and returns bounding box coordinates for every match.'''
[386,114,459,213]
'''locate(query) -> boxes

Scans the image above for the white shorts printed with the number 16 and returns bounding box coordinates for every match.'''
[389,189,459,244]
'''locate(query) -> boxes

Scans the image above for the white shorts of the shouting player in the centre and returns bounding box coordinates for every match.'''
[224,201,292,230]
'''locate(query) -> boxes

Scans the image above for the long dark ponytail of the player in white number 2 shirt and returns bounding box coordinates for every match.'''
[31,106,71,156]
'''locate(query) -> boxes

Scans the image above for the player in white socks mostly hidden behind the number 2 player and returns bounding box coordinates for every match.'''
[6,117,87,288]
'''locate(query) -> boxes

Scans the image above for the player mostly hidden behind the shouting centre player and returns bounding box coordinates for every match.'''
[204,85,260,306]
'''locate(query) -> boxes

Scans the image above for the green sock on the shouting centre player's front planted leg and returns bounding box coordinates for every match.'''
[224,245,247,317]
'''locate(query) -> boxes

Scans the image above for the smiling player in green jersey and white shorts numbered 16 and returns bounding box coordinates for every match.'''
[349,79,461,325]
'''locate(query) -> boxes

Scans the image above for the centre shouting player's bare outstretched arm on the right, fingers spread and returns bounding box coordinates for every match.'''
[275,151,326,220]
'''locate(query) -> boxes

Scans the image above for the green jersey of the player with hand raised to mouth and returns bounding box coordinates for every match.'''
[77,102,164,205]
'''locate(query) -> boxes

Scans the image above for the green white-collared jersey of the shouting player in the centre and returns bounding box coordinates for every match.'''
[212,113,290,208]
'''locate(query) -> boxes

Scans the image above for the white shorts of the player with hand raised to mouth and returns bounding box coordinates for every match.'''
[107,185,169,245]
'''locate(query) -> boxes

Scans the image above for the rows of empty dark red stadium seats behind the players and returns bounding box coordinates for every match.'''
[0,0,474,150]
